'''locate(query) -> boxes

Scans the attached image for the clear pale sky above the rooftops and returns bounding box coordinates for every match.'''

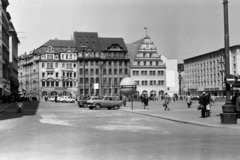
[7,0,240,63]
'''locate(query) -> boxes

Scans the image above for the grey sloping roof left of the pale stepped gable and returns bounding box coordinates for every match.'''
[126,38,144,62]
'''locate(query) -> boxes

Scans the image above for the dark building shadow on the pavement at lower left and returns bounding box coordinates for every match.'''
[0,101,40,121]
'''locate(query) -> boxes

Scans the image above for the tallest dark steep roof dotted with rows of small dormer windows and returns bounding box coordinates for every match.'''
[74,32,101,52]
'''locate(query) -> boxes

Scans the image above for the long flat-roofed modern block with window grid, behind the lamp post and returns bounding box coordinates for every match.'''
[184,45,240,96]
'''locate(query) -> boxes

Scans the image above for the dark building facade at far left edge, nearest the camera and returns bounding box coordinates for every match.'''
[0,0,11,99]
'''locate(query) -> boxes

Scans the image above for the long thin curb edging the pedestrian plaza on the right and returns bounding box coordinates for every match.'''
[121,110,232,128]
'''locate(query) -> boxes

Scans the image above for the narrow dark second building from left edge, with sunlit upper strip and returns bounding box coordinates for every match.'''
[9,22,20,96]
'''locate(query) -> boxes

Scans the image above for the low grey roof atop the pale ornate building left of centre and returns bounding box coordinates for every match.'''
[39,39,75,48]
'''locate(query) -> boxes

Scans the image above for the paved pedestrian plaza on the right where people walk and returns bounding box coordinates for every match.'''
[121,101,240,129]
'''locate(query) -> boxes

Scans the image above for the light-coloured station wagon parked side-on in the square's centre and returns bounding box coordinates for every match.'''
[87,96,122,110]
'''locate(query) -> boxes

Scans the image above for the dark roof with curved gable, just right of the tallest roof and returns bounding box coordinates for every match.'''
[99,37,127,51]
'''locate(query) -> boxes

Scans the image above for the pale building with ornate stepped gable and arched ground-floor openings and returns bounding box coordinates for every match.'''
[127,35,167,97]
